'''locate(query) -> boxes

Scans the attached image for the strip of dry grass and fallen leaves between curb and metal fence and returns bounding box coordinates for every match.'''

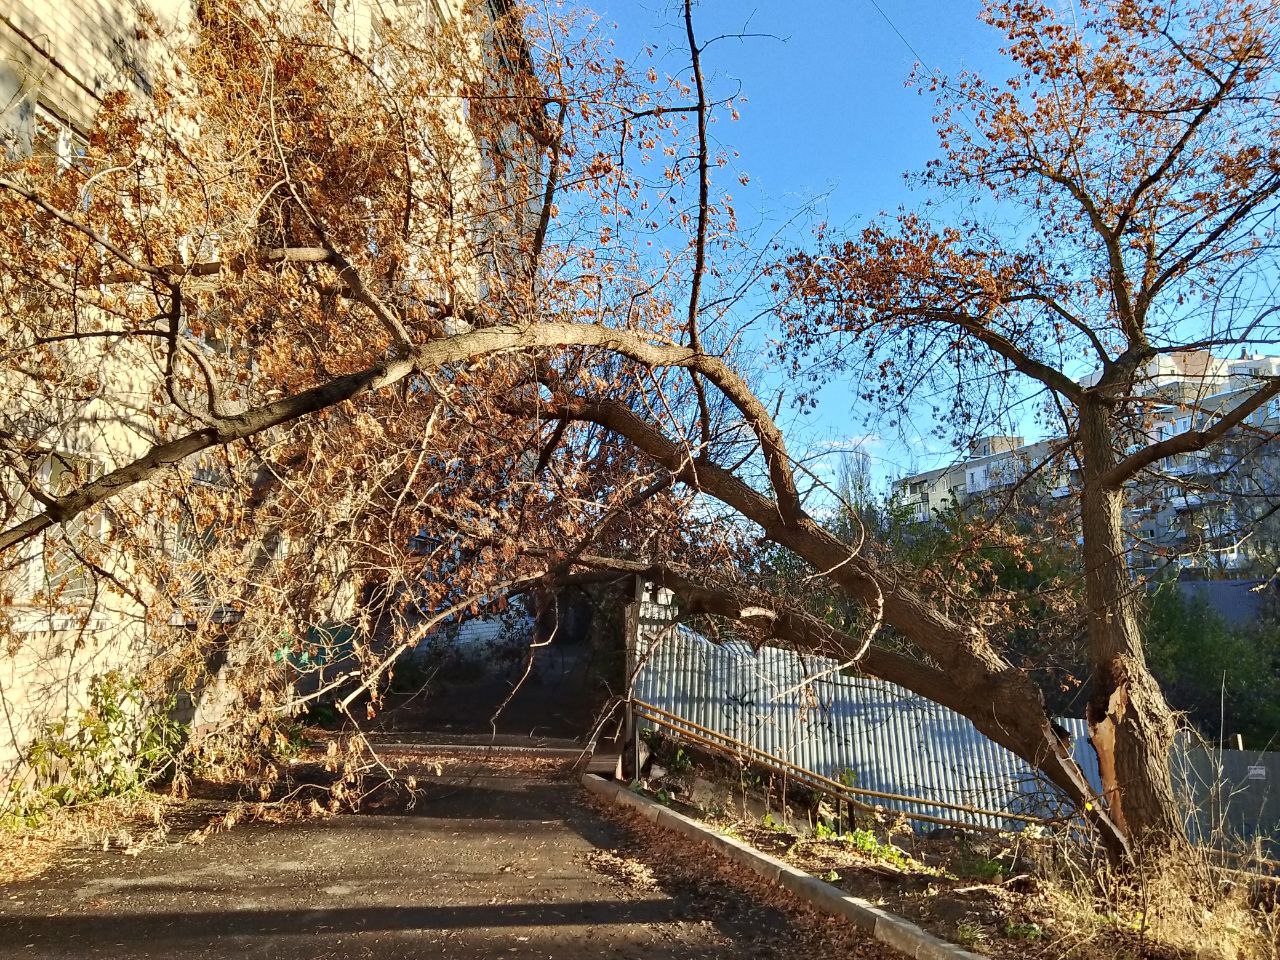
[634,773,1280,960]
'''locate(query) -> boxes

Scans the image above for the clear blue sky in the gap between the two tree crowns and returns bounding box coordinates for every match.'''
[590,0,1018,491]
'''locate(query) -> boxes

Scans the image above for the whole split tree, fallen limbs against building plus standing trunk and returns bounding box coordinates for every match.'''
[0,0,1280,858]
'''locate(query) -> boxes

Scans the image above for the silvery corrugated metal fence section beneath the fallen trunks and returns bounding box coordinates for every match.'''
[632,616,1097,831]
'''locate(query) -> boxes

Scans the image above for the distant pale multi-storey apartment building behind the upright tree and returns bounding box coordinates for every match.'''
[892,351,1280,577]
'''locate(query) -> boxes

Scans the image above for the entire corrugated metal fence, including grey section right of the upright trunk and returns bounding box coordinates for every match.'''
[630,594,1280,856]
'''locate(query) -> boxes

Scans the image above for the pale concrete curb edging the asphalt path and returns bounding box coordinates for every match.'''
[582,774,987,960]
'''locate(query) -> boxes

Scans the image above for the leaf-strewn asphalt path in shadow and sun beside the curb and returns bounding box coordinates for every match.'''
[0,762,893,960]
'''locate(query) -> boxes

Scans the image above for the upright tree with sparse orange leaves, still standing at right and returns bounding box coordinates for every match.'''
[787,3,1280,855]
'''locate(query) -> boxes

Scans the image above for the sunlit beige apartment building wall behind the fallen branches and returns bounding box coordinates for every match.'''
[0,0,537,791]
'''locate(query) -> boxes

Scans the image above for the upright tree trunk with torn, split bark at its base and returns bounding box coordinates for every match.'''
[1080,401,1185,855]
